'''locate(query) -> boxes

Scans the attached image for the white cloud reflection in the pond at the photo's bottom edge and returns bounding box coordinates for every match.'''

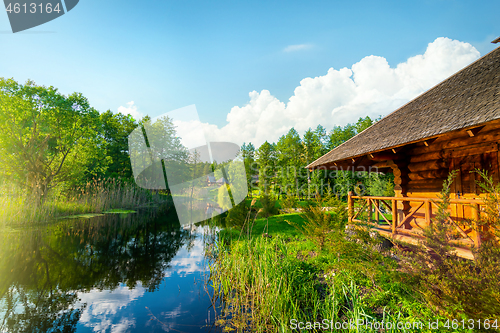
[80,283,146,333]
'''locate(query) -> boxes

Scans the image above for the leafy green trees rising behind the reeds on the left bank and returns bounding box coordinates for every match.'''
[0,78,143,197]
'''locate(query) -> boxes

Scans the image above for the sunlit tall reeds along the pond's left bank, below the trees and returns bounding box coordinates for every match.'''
[0,179,165,226]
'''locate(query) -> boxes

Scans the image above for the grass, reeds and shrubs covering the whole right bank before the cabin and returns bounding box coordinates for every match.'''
[209,174,500,332]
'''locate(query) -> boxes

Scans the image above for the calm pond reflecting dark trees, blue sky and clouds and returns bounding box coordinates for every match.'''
[0,212,221,332]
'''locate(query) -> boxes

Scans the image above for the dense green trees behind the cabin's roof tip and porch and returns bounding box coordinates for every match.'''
[241,116,394,197]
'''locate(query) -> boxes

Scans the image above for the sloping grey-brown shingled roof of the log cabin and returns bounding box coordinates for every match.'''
[307,47,500,168]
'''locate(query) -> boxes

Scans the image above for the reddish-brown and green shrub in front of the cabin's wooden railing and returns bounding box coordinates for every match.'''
[401,172,500,320]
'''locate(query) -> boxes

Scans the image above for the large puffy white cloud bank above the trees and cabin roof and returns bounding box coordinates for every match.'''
[198,37,480,146]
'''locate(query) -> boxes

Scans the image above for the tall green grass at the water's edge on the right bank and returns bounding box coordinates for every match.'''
[205,236,428,332]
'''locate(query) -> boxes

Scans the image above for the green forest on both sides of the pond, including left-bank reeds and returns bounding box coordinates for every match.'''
[0,78,393,223]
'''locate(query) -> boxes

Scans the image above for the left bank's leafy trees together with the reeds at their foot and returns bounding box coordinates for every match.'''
[0,78,175,226]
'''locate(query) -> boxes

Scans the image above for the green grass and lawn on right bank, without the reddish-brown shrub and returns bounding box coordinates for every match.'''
[210,214,450,332]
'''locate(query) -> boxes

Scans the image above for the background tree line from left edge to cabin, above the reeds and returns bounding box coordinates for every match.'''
[0,78,392,202]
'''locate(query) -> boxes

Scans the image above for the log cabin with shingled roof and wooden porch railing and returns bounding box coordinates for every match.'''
[306,43,500,258]
